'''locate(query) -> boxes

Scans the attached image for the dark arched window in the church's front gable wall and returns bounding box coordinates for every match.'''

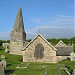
[34,43,44,59]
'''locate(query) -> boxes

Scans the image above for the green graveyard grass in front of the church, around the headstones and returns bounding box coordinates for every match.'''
[0,46,75,75]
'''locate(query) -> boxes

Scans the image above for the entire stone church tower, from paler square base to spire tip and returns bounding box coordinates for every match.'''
[10,8,26,55]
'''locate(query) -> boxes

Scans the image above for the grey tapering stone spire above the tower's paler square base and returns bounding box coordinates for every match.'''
[11,8,26,41]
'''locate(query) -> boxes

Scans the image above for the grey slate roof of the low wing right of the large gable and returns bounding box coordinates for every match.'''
[55,46,73,56]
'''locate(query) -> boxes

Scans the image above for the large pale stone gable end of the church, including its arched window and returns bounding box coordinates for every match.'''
[23,34,57,63]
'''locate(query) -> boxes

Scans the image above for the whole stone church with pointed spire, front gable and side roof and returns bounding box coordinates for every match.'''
[9,8,73,63]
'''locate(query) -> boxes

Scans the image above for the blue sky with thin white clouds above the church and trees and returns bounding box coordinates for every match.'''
[0,0,75,40]
